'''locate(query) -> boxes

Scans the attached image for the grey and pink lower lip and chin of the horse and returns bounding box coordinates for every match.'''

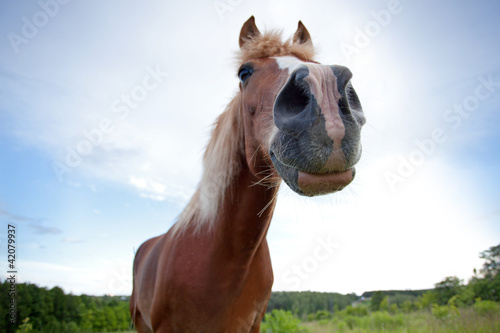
[270,151,356,197]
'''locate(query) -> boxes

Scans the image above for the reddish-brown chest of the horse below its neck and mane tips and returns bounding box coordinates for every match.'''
[151,236,273,333]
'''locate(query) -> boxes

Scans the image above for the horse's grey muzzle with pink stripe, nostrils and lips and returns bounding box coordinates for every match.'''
[269,63,365,196]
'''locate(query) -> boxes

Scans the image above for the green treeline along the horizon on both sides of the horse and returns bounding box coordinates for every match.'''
[0,245,500,333]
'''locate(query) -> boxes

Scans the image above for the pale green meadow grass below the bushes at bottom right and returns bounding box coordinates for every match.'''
[302,308,500,333]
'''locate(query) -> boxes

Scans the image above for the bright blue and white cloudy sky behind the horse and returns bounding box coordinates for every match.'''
[0,0,500,295]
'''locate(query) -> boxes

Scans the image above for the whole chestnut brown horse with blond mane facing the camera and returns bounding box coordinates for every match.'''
[130,16,365,333]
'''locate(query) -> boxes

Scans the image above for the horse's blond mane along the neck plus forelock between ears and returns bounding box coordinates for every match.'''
[172,31,314,234]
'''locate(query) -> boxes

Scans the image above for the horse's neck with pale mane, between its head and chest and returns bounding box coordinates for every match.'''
[178,94,279,256]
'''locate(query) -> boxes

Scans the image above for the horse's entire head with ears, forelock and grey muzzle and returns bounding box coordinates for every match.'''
[238,16,365,196]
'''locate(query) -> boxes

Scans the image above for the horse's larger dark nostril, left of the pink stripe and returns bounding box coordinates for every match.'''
[274,67,310,129]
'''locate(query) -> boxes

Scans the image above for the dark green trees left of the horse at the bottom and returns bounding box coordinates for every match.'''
[0,281,131,333]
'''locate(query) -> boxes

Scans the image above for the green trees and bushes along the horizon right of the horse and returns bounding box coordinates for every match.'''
[267,245,500,320]
